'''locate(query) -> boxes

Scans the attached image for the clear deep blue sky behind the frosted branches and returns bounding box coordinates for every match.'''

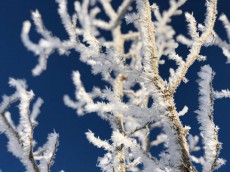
[0,0,230,172]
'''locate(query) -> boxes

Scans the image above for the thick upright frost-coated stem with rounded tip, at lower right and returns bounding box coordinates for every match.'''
[196,65,226,172]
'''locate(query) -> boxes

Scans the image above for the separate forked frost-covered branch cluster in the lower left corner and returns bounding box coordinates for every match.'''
[0,78,58,172]
